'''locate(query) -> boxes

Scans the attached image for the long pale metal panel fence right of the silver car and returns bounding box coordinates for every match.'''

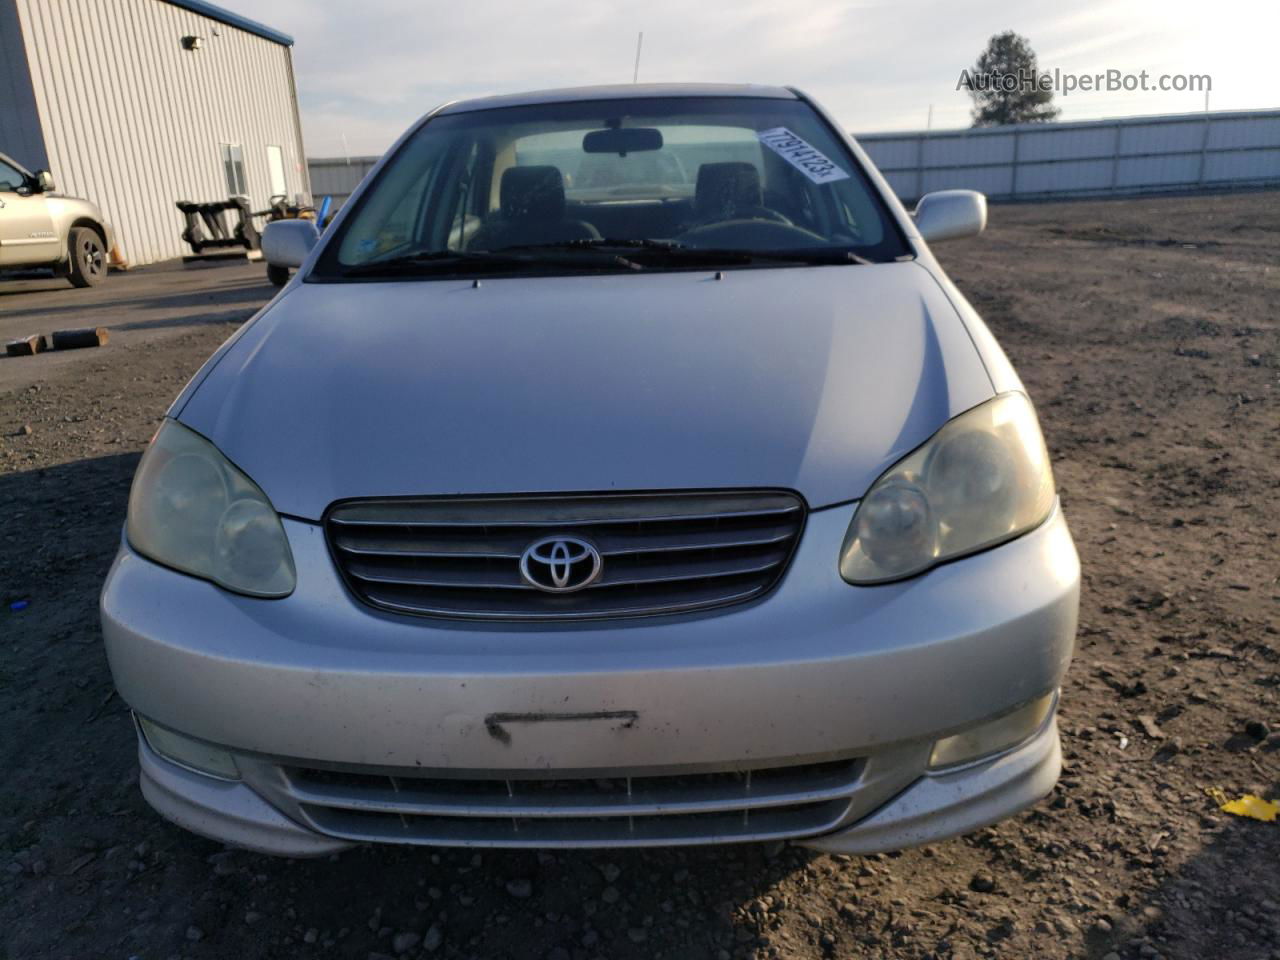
[855,110,1280,201]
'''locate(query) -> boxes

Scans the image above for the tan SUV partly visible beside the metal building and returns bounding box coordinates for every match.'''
[0,154,113,287]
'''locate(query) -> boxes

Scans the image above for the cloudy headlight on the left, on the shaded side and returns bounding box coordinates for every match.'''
[125,420,297,596]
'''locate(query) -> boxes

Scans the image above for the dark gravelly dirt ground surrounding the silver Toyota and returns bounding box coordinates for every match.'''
[0,193,1280,960]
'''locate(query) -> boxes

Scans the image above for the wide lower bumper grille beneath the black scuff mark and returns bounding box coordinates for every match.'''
[282,759,863,846]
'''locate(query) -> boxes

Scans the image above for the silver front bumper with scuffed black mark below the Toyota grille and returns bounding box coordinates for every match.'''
[102,507,1079,855]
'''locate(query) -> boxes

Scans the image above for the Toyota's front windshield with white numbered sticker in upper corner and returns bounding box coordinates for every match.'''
[314,97,910,279]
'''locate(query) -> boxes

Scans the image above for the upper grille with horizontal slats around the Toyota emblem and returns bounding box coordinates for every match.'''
[325,492,805,620]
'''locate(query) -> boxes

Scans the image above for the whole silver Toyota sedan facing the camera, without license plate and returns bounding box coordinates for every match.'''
[101,86,1079,855]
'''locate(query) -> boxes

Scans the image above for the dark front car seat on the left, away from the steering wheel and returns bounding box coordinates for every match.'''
[467,165,600,250]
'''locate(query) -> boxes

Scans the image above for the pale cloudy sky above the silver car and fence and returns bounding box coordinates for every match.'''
[218,0,1280,157]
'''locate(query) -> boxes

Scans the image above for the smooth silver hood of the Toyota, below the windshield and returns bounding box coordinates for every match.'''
[175,262,992,520]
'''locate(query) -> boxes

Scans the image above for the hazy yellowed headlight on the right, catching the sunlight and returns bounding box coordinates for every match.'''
[840,393,1053,584]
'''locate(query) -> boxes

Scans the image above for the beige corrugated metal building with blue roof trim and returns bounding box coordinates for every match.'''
[0,0,310,265]
